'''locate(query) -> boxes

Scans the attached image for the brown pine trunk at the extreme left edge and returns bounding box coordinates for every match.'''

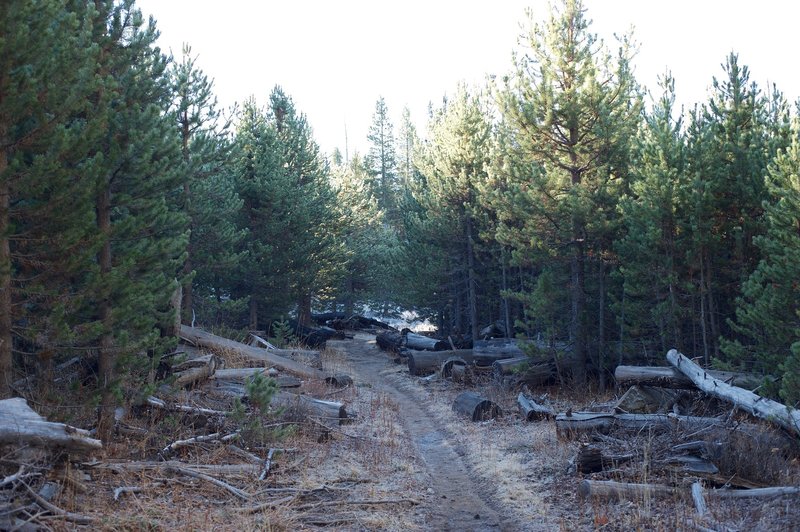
[0,145,14,399]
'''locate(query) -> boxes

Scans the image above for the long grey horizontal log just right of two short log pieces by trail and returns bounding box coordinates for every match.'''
[556,412,724,435]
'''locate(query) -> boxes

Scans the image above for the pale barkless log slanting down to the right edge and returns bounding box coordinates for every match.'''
[667,349,800,435]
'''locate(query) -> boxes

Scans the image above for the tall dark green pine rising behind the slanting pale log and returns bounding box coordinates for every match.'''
[686,54,778,363]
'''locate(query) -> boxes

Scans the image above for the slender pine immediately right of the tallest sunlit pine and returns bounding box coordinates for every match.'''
[615,74,688,358]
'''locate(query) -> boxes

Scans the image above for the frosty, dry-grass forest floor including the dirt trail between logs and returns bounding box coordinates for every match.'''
[10,332,800,531]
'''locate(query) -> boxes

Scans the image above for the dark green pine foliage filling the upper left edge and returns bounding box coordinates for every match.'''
[0,0,102,397]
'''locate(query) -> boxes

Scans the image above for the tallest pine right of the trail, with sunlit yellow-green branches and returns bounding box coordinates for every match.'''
[497,0,640,382]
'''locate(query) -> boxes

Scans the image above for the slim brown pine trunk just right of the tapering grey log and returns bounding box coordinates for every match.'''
[97,184,114,442]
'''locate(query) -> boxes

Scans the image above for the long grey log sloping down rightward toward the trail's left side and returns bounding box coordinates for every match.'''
[181,325,349,386]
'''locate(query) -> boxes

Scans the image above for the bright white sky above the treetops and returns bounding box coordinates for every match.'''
[137,0,800,155]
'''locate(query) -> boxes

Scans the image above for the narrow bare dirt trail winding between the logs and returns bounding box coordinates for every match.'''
[328,334,517,531]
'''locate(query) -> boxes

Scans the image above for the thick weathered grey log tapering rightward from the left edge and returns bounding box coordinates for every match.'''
[0,397,103,453]
